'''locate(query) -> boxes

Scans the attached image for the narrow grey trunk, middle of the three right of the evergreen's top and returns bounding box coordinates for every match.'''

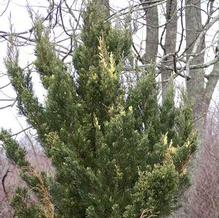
[161,0,177,100]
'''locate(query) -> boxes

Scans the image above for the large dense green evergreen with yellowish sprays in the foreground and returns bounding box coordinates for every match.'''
[0,0,196,218]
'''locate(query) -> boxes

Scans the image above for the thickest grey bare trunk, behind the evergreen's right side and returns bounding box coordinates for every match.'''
[185,0,206,135]
